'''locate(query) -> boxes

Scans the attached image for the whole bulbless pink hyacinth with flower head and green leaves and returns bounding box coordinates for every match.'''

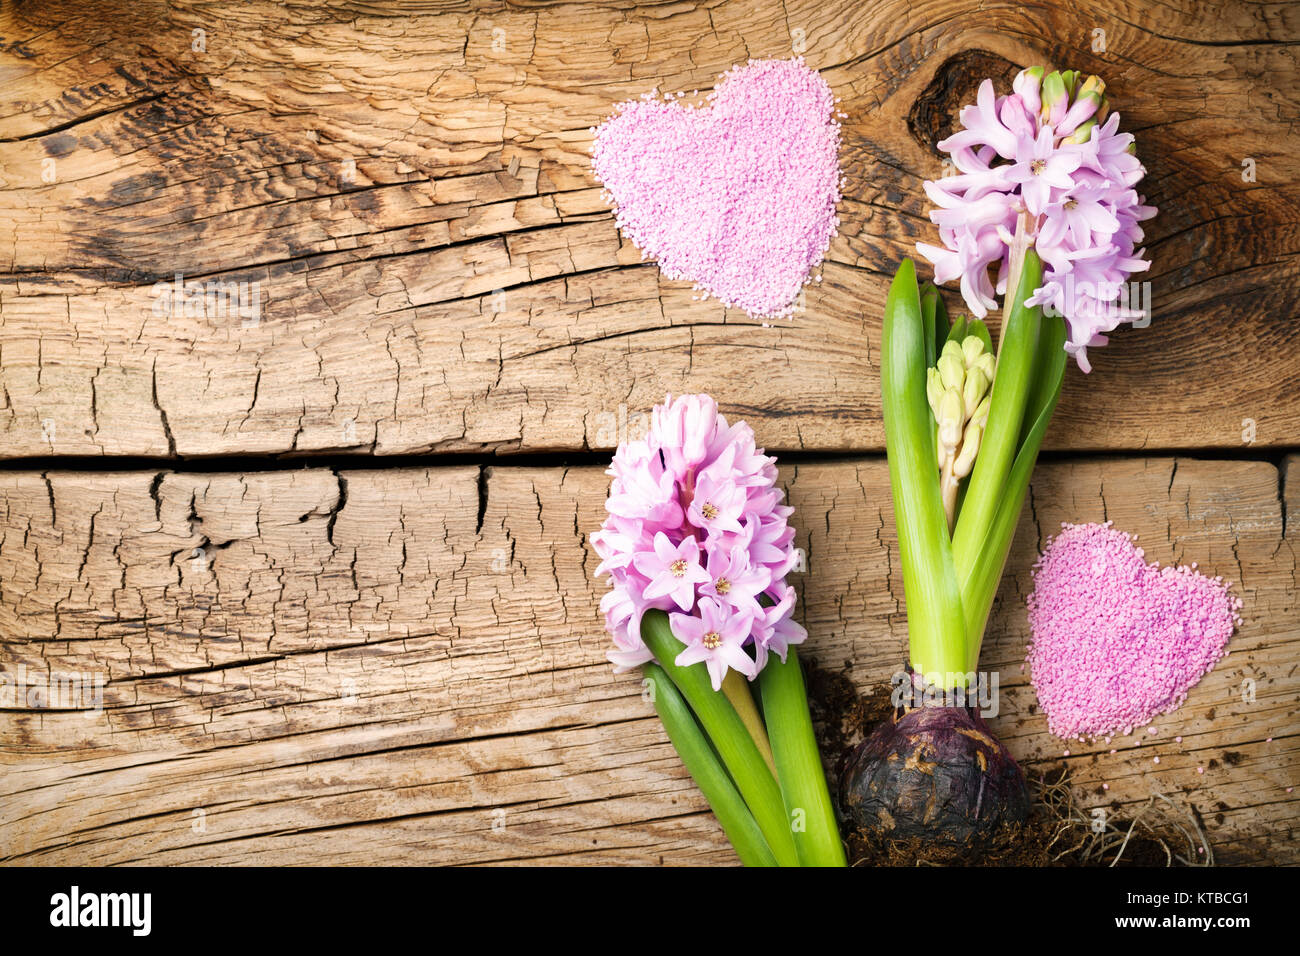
[590,395,844,865]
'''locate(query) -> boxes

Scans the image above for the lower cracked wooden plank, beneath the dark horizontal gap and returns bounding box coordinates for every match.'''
[0,458,1300,864]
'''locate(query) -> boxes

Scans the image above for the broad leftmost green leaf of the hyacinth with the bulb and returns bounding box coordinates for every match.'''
[880,259,966,680]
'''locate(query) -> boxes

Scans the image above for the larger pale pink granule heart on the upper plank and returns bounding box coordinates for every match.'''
[592,57,840,317]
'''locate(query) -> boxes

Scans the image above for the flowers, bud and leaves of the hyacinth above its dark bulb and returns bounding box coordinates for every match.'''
[880,68,1156,685]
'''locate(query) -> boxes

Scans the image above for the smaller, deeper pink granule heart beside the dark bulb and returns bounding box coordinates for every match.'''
[1027,522,1242,737]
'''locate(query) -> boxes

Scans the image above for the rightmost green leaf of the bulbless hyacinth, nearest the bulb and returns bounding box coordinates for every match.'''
[758,648,848,866]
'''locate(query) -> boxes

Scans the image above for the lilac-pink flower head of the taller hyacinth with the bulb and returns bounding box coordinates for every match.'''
[917,66,1156,372]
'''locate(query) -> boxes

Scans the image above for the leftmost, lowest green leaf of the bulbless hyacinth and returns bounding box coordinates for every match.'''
[644,663,776,866]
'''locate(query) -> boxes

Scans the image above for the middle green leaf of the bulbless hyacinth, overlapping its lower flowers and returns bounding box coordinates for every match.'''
[641,610,800,866]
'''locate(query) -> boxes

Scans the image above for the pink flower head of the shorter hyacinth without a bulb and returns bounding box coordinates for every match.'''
[592,395,807,691]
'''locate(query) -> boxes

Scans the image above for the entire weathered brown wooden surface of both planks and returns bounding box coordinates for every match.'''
[0,0,1300,864]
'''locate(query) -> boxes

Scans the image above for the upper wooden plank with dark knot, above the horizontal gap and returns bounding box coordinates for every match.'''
[0,0,1300,458]
